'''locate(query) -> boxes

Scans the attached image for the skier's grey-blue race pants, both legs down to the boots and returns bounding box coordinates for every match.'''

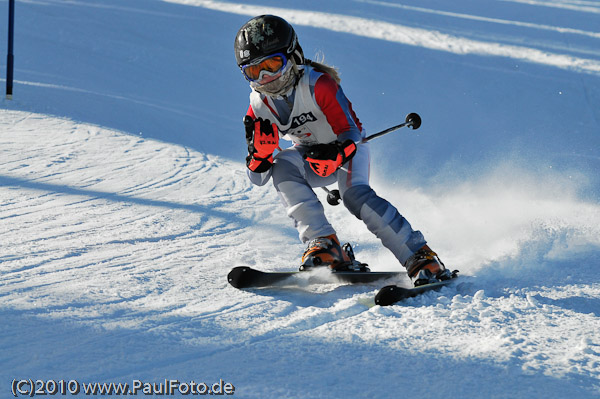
[271,143,426,265]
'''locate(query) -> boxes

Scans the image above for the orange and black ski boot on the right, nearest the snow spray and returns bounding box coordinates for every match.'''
[404,245,452,287]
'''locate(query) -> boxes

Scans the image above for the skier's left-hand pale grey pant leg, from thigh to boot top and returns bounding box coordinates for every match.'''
[272,147,335,242]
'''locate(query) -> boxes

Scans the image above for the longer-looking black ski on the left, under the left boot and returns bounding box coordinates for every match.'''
[227,266,406,288]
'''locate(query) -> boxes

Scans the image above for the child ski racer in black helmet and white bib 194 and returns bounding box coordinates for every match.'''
[234,15,451,285]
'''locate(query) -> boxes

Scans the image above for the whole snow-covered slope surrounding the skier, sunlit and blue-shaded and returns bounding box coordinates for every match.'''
[0,0,600,399]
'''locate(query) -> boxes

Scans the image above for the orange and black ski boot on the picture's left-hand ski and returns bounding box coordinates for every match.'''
[300,234,369,271]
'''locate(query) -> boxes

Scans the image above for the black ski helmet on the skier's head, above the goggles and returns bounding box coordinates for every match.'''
[233,15,304,68]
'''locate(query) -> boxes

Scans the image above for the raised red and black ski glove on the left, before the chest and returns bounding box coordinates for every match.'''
[244,115,279,173]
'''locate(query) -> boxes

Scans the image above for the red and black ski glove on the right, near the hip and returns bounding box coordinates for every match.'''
[303,140,356,177]
